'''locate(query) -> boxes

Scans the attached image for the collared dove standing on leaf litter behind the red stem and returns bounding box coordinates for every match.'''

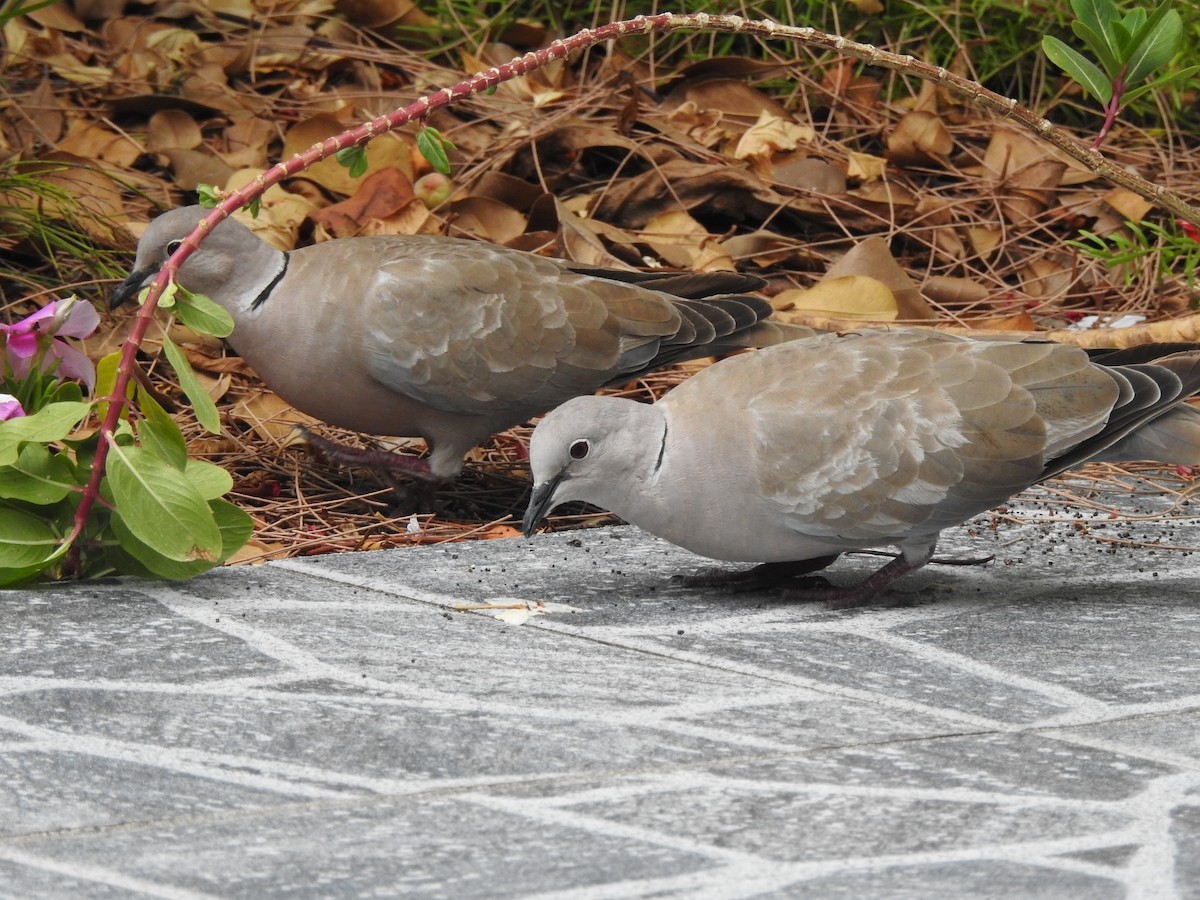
[113,206,788,481]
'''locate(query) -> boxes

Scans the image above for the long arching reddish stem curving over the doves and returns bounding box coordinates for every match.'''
[66,13,1200,571]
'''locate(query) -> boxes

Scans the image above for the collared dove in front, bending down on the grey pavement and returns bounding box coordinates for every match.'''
[523,330,1200,606]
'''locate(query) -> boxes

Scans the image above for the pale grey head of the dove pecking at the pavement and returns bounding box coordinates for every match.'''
[521,397,666,536]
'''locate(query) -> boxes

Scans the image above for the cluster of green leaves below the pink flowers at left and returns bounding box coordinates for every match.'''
[0,286,253,586]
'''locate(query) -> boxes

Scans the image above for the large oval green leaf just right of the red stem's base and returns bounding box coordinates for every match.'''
[108,446,221,563]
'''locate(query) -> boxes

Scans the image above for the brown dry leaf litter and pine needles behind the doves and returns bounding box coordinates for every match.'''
[0,0,1200,562]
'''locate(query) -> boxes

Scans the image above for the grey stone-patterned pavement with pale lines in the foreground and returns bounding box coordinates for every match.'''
[0,487,1200,900]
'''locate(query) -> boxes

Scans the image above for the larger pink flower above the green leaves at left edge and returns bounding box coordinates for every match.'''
[0,296,100,391]
